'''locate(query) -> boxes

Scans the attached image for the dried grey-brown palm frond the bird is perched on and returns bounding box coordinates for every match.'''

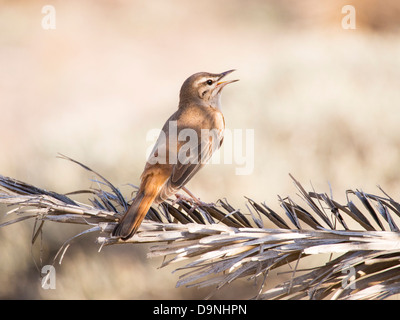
[0,157,400,299]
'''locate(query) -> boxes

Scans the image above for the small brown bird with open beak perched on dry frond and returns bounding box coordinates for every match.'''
[113,70,238,240]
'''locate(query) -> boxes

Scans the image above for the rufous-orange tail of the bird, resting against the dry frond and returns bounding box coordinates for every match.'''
[112,184,157,240]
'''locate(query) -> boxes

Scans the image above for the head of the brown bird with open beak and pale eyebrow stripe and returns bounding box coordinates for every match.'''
[179,69,238,110]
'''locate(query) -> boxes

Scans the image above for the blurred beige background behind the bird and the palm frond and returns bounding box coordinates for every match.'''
[0,0,400,299]
